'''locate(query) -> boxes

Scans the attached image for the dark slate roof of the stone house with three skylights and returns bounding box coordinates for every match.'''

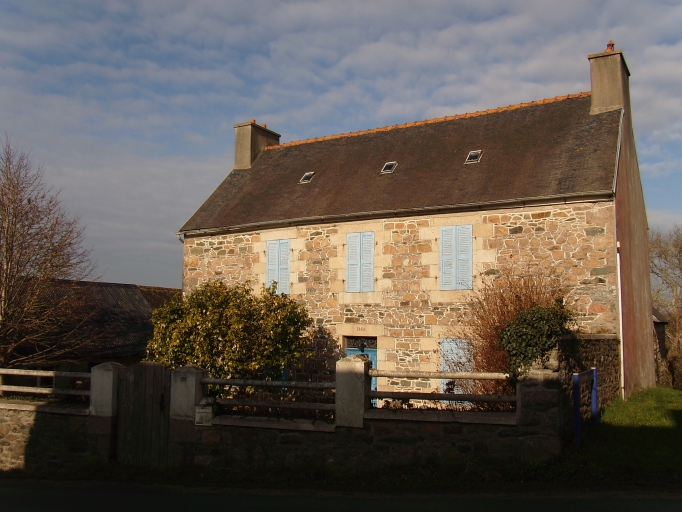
[180,93,620,233]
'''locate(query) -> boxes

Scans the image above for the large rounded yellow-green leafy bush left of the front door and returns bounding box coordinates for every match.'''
[147,281,312,379]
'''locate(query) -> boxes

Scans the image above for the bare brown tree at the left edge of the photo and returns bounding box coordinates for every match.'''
[0,137,94,367]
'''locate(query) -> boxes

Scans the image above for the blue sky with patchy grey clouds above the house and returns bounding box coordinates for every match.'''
[0,0,682,287]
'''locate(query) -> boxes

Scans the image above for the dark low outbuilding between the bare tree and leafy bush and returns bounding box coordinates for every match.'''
[70,282,181,360]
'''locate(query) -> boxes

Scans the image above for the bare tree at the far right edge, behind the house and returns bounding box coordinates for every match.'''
[649,225,682,389]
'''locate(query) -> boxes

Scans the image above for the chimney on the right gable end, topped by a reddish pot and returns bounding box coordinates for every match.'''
[587,41,630,115]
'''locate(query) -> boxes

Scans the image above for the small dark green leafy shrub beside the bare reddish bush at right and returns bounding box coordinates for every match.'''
[500,300,573,379]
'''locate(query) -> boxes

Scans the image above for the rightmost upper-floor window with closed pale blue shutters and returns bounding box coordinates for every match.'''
[440,225,474,290]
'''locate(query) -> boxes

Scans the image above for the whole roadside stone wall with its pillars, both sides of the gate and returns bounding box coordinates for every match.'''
[0,362,563,473]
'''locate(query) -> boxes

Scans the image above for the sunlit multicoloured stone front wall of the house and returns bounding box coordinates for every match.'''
[183,201,619,389]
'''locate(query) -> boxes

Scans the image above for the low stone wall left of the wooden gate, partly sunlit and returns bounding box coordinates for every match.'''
[0,400,111,473]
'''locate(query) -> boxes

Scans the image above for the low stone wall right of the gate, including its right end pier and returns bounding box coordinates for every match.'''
[169,370,562,471]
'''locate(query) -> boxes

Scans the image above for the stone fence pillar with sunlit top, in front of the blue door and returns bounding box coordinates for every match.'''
[334,355,371,428]
